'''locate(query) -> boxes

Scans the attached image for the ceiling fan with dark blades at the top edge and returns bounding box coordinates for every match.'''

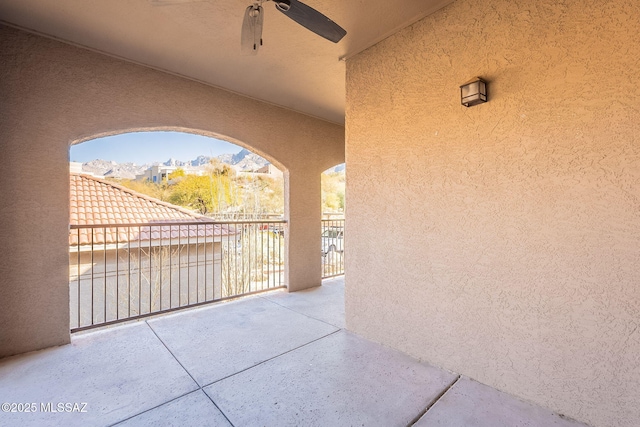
[151,0,347,55]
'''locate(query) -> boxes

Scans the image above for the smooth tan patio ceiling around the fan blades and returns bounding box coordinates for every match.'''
[0,0,453,123]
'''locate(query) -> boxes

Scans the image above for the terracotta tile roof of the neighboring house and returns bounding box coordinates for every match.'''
[69,173,235,246]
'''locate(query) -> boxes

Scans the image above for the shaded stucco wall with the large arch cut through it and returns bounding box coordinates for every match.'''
[0,26,344,357]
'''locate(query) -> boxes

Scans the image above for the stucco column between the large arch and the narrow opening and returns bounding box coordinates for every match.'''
[284,169,322,292]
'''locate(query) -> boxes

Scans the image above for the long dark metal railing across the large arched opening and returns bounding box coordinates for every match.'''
[69,221,286,332]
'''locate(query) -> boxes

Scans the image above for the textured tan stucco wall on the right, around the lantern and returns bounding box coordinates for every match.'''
[346,0,640,427]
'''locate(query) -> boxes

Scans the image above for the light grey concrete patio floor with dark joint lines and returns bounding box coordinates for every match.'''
[0,278,583,427]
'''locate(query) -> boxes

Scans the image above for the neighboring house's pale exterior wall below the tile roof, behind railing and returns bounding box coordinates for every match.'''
[69,242,227,329]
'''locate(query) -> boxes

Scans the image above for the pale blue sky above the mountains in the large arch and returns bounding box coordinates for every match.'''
[69,132,242,165]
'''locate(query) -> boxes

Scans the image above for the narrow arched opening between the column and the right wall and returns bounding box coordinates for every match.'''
[320,163,346,278]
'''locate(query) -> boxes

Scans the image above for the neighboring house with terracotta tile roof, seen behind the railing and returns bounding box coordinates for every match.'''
[69,173,237,328]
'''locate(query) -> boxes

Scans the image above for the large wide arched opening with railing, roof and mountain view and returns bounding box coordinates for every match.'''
[69,132,285,331]
